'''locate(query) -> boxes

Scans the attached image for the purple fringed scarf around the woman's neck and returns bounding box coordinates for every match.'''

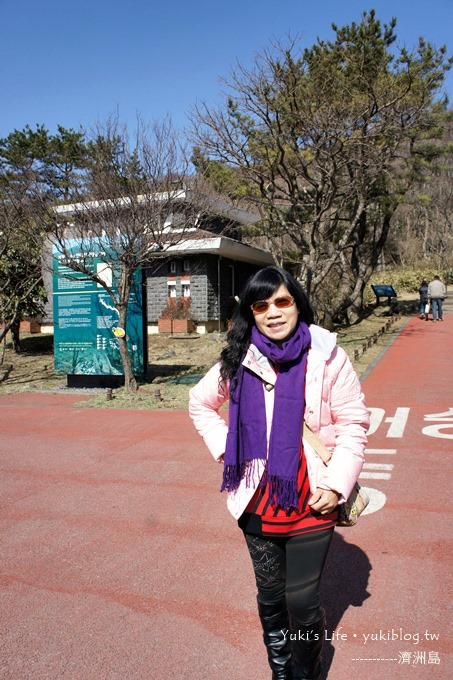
[220,322,311,510]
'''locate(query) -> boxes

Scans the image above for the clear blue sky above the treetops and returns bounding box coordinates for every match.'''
[0,0,453,137]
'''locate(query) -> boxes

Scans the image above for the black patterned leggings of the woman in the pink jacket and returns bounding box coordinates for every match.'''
[244,529,334,626]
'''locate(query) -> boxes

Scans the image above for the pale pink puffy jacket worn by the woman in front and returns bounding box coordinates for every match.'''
[189,325,369,519]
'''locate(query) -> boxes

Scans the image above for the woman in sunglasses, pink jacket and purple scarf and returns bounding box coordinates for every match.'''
[189,266,369,680]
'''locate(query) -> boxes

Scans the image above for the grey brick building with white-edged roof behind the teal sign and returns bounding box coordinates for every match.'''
[43,188,274,333]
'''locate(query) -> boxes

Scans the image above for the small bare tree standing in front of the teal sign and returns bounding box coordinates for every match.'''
[48,120,212,391]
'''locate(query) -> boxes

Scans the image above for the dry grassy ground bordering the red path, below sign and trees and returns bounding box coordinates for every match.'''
[0,301,413,410]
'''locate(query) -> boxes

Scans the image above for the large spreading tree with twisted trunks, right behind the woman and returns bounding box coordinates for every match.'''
[193,11,450,323]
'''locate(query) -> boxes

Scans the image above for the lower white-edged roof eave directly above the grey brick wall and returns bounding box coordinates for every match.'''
[166,236,274,265]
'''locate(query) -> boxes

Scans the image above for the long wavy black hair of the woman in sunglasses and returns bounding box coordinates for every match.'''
[220,266,314,380]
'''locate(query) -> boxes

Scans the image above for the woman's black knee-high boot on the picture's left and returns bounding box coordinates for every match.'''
[258,600,293,680]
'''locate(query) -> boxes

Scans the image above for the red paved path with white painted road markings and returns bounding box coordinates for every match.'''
[0,315,453,680]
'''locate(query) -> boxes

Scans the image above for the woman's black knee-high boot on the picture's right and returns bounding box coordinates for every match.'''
[290,609,325,680]
